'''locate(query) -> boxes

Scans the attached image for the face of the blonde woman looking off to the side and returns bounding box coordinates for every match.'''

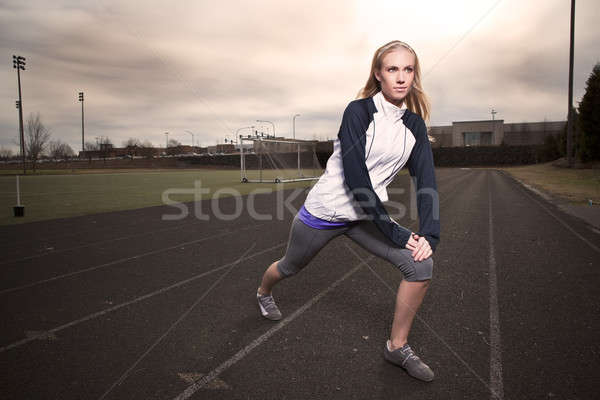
[375,47,415,107]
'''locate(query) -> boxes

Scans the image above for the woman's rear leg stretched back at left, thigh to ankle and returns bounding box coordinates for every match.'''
[258,214,348,294]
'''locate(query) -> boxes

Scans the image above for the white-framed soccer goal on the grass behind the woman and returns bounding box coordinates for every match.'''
[240,136,323,183]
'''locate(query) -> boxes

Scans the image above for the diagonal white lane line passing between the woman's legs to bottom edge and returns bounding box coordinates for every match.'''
[175,256,374,400]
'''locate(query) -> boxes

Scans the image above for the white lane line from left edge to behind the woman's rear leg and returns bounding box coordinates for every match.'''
[0,241,287,353]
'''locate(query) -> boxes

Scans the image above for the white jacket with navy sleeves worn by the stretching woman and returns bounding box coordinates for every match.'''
[304,91,440,251]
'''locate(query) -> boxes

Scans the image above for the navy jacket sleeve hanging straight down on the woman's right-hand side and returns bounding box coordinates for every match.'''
[407,119,440,251]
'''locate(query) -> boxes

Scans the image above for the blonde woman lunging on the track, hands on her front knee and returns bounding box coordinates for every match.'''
[257,40,440,381]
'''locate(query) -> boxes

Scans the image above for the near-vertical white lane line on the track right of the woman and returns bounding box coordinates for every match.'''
[487,171,504,400]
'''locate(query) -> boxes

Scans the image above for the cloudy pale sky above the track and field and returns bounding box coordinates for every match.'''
[0,0,600,152]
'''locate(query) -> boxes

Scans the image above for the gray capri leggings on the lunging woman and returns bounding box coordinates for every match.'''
[277,214,433,282]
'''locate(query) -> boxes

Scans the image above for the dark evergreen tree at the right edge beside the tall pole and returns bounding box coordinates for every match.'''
[579,63,600,162]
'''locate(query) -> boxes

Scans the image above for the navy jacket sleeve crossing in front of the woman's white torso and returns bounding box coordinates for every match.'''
[338,105,412,248]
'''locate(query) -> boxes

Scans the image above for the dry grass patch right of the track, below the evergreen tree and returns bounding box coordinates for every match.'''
[498,162,600,204]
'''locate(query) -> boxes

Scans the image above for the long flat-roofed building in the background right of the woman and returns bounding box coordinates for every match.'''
[428,119,566,147]
